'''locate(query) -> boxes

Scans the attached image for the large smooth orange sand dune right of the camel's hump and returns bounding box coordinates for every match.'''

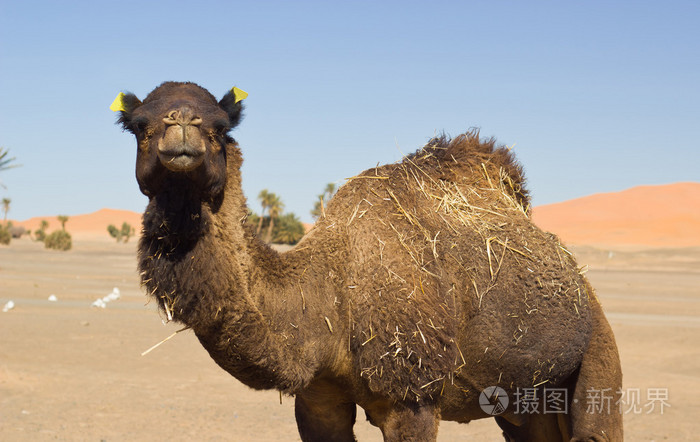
[532,183,700,247]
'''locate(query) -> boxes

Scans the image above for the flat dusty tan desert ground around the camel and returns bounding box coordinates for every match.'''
[0,239,700,441]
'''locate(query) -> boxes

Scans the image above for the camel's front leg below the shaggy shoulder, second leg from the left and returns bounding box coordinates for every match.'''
[378,404,440,442]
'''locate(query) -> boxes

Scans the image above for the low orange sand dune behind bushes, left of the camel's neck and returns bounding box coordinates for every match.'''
[14,209,141,238]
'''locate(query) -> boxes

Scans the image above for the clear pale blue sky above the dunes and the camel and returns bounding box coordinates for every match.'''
[0,0,700,222]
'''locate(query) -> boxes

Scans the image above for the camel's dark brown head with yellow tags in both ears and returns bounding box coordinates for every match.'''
[111,82,245,197]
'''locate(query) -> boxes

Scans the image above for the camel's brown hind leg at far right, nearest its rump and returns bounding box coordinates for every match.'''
[569,294,622,441]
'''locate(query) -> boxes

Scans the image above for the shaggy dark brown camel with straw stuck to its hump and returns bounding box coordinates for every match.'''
[113,82,622,441]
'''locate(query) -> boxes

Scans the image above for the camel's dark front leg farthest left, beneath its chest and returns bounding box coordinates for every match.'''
[294,394,357,442]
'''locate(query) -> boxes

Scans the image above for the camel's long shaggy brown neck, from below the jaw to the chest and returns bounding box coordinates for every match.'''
[139,147,318,391]
